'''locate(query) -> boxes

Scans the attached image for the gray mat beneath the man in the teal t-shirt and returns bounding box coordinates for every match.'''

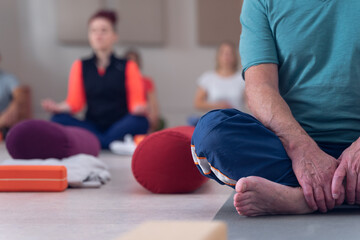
[214,193,360,240]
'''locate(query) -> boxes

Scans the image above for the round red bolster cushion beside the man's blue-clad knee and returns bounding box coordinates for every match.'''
[132,127,208,193]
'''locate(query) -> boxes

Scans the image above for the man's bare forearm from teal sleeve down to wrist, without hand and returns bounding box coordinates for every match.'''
[246,65,316,159]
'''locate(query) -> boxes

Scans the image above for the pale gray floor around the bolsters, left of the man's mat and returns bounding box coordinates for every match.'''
[0,144,232,240]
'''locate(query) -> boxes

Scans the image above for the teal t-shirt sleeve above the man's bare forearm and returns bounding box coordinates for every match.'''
[240,0,279,76]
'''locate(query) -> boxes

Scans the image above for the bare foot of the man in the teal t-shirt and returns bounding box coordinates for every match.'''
[234,177,313,216]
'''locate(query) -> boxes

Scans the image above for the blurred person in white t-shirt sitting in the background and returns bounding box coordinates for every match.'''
[194,42,246,119]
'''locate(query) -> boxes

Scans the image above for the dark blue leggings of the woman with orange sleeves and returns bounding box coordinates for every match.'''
[51,113,149,149]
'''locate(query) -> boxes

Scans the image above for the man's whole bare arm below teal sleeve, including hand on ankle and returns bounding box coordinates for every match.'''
[245,64,344,212]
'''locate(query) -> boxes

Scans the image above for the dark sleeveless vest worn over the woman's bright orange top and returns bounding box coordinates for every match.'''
[82,55,128,132]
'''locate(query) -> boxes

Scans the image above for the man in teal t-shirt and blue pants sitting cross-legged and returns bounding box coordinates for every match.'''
[192,0,360,216]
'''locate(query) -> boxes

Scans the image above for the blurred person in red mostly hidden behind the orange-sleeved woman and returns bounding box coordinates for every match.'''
[125,48,165,133]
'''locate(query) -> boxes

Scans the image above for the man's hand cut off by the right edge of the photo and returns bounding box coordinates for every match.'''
[332,139,360,204]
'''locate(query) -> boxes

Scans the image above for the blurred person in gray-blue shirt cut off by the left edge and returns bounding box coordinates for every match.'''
[0,51,31,140]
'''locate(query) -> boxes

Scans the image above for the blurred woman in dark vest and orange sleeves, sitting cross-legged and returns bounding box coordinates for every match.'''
[42,10,149,149]
